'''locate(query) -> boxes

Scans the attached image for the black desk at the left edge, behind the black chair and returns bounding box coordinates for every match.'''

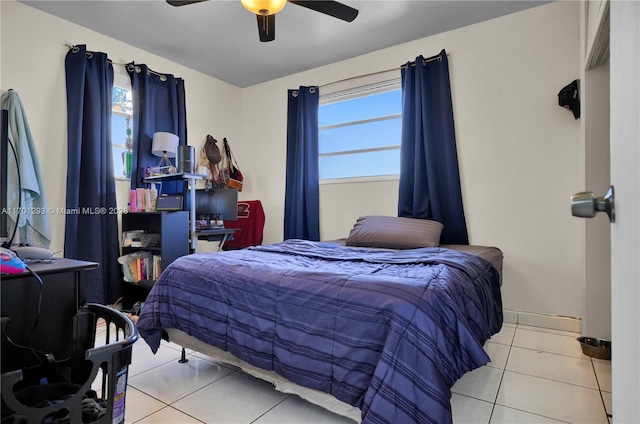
[0,259,99,370]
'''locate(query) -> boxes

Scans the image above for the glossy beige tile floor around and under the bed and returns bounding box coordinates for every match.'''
[97,323,611,424]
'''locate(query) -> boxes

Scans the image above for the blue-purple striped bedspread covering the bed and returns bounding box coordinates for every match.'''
[138,240,502,423]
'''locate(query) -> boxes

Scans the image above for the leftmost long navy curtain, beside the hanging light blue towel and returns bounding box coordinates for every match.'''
[64,45,121,303]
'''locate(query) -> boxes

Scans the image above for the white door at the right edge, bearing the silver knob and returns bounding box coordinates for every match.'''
[610,0,640,423]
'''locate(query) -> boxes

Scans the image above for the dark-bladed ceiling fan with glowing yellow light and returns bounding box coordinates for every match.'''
[167,0,358,42]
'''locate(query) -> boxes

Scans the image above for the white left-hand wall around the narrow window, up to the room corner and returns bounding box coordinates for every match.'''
[0,1,241,252]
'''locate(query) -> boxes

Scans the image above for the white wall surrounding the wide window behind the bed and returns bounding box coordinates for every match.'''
[237,2,584,317]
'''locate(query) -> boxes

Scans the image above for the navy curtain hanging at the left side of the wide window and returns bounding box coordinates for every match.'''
[284,87,320,241]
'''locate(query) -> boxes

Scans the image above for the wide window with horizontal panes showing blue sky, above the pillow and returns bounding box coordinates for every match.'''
[318,79,402,182]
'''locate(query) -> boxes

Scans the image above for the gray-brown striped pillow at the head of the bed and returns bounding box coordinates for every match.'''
[346,216,443,249]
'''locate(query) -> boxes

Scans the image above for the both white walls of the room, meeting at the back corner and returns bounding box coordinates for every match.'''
[0,1,585,316]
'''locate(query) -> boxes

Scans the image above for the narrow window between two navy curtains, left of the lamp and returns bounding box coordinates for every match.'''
[111,73,133,179]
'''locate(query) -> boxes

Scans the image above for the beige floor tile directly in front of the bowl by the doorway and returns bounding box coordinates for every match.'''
[506,346,598,390]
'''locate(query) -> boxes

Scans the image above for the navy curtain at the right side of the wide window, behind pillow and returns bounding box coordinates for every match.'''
[398,50,469,244]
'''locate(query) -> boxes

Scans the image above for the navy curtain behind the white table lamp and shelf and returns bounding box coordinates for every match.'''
[127,63,187,193]
